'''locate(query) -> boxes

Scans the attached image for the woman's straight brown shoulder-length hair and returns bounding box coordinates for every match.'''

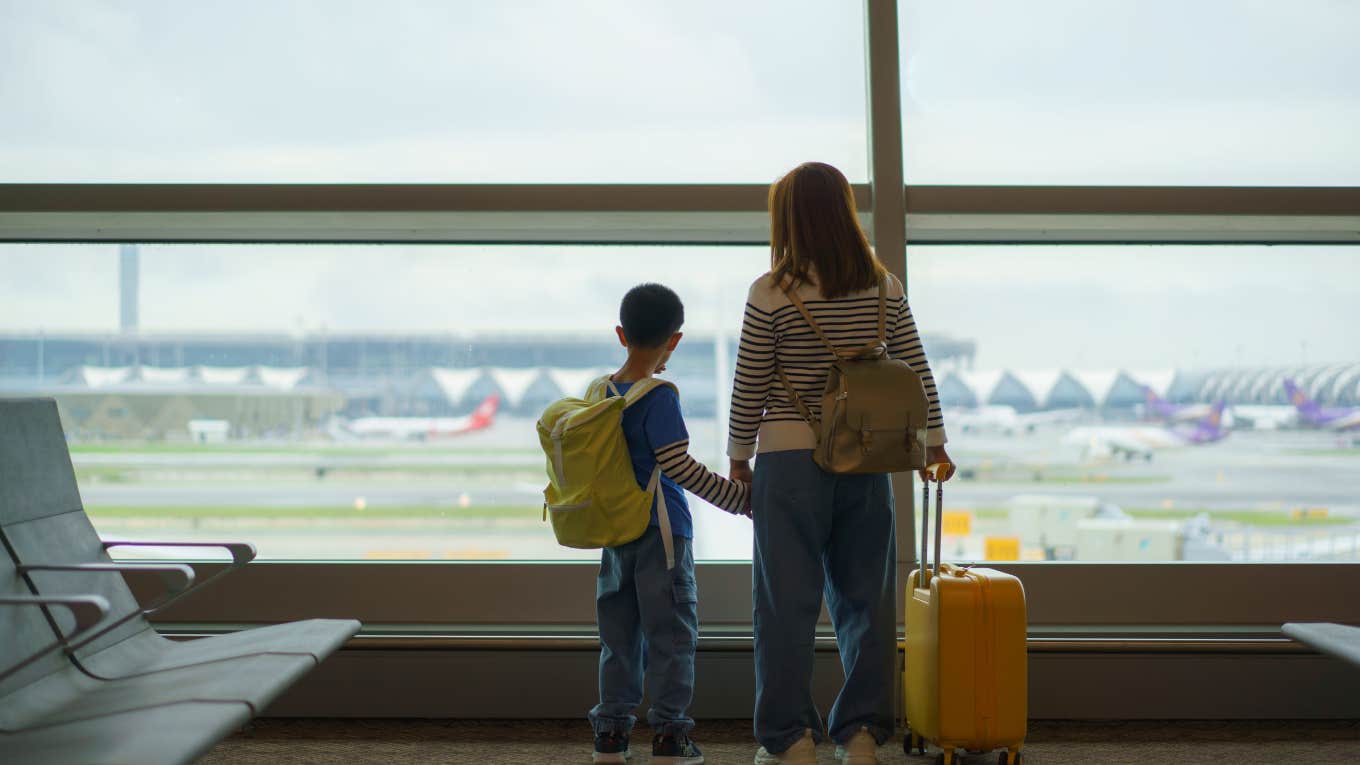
[770,162,887,299]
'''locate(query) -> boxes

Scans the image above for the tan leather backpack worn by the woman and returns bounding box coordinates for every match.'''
[775,279,930,474]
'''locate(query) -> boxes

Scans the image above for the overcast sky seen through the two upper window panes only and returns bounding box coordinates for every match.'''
[0,0,1360,185]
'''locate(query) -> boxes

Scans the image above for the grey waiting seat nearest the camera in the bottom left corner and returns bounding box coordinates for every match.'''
[0,536,289,765]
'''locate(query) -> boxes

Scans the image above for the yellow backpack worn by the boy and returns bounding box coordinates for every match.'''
[539,376,675,569]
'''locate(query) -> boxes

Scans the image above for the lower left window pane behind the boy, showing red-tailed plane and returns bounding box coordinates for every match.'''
[0,244,768,561]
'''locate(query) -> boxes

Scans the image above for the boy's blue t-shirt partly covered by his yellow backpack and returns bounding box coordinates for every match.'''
[613,383,694,539]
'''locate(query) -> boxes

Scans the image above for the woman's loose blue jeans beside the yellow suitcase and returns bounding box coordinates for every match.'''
[751,449,898,753]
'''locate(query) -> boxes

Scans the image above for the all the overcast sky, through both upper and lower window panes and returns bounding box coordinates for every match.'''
[0,0,1360,368]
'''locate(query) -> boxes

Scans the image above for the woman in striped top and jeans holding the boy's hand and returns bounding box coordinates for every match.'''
[728,162,952,765]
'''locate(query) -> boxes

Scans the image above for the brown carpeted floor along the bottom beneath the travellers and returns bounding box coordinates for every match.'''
[200,719,1360,765]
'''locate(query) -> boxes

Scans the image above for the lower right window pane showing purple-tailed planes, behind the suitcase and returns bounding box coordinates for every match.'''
[907,245,1360,562]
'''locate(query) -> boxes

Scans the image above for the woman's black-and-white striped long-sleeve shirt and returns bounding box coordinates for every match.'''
[728,274,945,460]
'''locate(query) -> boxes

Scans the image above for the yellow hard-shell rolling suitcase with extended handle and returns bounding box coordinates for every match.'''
[902,470,1027,765]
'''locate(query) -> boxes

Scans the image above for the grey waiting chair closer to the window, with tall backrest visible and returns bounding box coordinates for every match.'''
[0,399,360,678]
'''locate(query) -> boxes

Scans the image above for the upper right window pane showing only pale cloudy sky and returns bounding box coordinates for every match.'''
[899,0,1360,185]
